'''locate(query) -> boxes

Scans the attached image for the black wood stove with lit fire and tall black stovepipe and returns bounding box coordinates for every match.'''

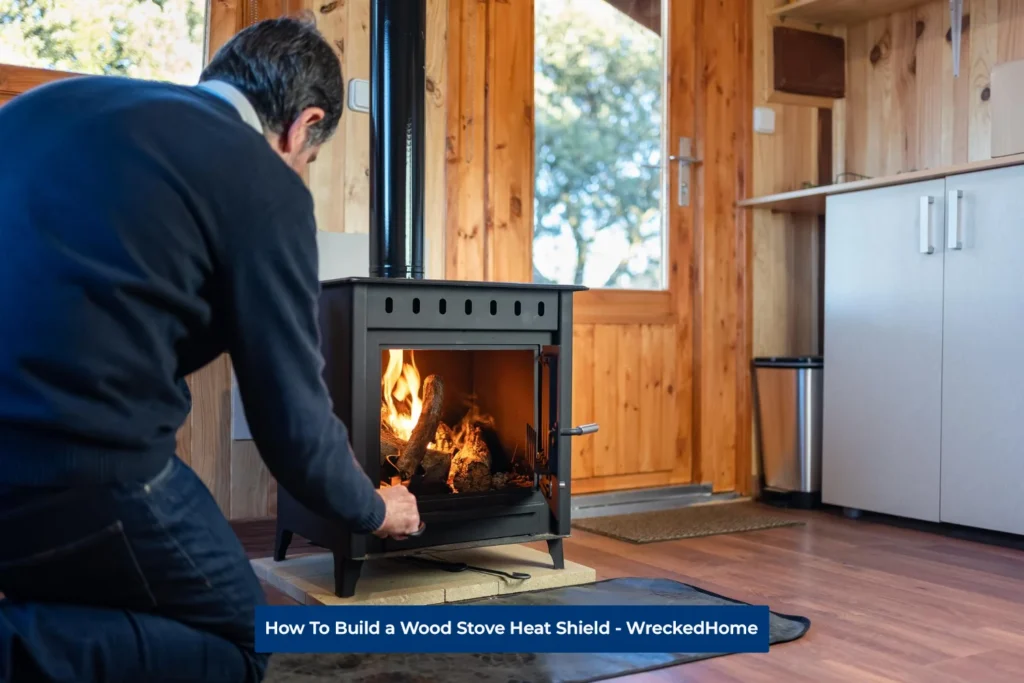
[274,0,597,597]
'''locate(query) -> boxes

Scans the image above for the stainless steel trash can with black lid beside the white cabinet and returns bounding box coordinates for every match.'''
[753,356,824,508]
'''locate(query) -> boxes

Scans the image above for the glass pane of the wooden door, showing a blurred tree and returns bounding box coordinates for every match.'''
[534,0,667,290]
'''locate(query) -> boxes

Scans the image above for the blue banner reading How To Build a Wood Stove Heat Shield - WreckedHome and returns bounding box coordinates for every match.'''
[256,604,769,654]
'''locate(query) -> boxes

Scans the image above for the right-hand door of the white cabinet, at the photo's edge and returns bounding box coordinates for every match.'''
[942,166,1024,533]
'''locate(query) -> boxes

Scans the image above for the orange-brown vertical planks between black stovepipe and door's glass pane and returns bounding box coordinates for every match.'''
[444,0,534,283]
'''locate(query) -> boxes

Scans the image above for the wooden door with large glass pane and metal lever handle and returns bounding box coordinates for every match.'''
[532,0,697,493]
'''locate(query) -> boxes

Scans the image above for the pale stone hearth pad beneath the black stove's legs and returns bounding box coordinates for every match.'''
[252,546,597,605]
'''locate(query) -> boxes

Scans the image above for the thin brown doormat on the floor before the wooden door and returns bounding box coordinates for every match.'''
[572,502,804,544]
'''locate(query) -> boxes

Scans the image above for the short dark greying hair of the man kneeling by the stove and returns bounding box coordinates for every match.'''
[200,17,345,145]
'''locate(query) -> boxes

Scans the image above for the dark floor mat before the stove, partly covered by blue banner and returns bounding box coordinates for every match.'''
[265,579,811,683]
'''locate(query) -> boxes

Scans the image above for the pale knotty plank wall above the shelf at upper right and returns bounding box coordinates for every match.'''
[844,0,1024,177]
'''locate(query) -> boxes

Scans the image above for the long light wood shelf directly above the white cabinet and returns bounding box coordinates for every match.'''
[736,154,1024,216]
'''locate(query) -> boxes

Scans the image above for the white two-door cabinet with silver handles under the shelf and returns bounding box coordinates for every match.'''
[822,166,1024,533]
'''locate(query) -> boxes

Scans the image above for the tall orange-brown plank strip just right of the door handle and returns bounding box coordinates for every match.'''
[693,0,754,493]
